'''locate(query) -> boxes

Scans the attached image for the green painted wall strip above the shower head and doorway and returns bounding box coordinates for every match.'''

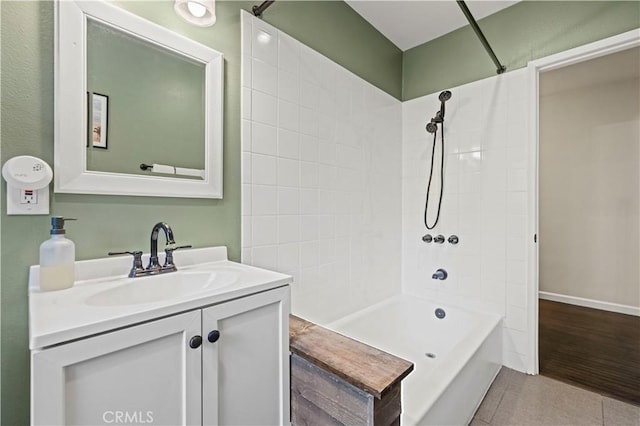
[402,1,640,100]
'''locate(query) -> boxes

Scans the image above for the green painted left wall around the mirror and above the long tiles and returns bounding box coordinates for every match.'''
[0,0,402,425]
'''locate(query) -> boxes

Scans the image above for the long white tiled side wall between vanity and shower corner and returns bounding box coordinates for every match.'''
[242,13,402,323]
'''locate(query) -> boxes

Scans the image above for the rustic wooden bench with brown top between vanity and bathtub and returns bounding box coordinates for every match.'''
[289,315,413,426]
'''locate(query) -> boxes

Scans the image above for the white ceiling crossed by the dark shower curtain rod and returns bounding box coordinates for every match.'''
[345,0,517,51]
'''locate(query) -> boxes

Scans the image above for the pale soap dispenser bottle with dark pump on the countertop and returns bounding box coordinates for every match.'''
[40,216,76,291]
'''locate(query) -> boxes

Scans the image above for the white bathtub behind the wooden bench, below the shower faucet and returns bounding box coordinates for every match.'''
[327,295,502,425]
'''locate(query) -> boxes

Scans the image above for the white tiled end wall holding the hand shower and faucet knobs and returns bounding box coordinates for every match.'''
[402,70,529,371]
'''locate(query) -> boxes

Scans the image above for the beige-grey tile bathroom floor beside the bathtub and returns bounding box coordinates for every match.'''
[471,367,640,426]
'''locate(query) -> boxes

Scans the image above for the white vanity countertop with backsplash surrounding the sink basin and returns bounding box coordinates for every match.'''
[29,247,292,349]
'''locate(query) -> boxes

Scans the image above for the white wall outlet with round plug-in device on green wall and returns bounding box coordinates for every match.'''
[2,155,53,214]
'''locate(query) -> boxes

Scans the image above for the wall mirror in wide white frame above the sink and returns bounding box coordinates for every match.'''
[54,0,223,198]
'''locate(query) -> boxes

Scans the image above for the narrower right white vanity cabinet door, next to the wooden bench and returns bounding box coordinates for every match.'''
[202,286,289,425]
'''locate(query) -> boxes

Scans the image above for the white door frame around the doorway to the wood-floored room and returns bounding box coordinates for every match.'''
[526,29,640,374]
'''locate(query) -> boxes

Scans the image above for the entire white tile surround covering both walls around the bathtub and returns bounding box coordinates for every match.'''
[242,13,530,371]
